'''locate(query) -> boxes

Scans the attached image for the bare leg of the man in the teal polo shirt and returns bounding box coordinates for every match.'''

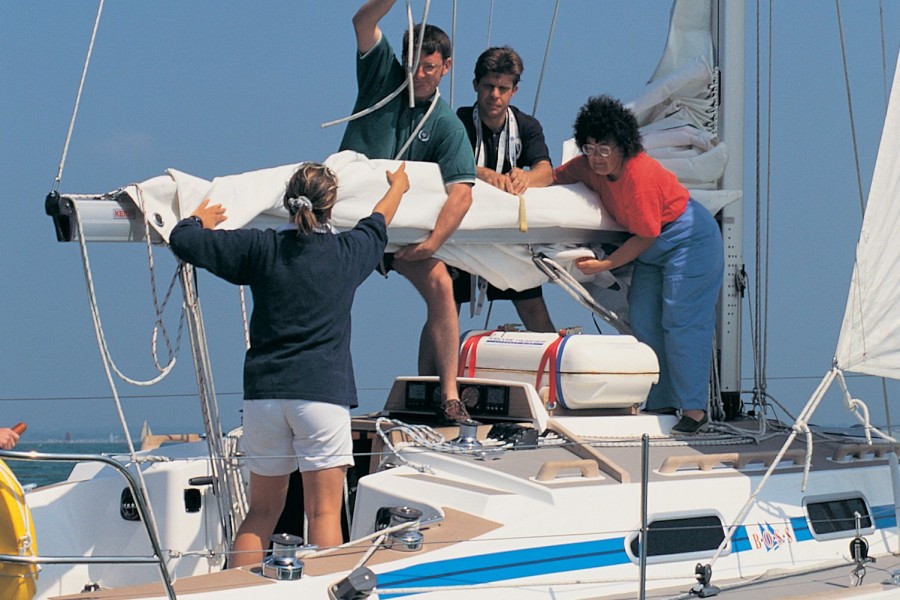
[394,258,459,400]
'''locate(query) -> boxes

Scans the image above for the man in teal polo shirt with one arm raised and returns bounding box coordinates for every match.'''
[341,0,475,421]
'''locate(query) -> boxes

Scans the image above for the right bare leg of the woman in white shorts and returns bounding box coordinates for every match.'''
[301,466,347,548]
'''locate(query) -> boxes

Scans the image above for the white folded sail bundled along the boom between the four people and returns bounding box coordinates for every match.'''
[134,151,622,289]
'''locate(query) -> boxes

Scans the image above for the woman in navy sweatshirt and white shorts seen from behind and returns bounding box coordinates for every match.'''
[169,163,409,567]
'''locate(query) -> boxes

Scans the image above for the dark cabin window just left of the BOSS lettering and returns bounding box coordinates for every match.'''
[630,515,725,558]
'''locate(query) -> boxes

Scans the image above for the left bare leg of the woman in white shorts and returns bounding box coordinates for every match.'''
[228,472,291,569]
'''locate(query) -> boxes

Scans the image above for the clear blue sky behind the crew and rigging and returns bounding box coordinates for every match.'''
[0,0,900,440]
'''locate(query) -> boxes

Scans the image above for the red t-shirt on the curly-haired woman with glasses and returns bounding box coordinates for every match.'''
[553,152,690,237]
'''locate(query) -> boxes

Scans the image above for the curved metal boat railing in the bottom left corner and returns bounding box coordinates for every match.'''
[0,450,176,600]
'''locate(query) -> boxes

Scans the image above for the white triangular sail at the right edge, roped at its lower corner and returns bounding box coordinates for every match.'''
[835,51,900,379]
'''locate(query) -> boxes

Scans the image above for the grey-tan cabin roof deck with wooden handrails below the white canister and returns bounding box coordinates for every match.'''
[360,415,896,488]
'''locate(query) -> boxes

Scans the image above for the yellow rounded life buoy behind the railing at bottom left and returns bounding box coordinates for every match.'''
[0,460,38,600]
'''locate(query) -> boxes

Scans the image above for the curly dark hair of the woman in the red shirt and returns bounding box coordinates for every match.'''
[574,95,644,158]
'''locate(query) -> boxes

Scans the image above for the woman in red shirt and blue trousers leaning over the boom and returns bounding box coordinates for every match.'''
[540,96,724,434]
